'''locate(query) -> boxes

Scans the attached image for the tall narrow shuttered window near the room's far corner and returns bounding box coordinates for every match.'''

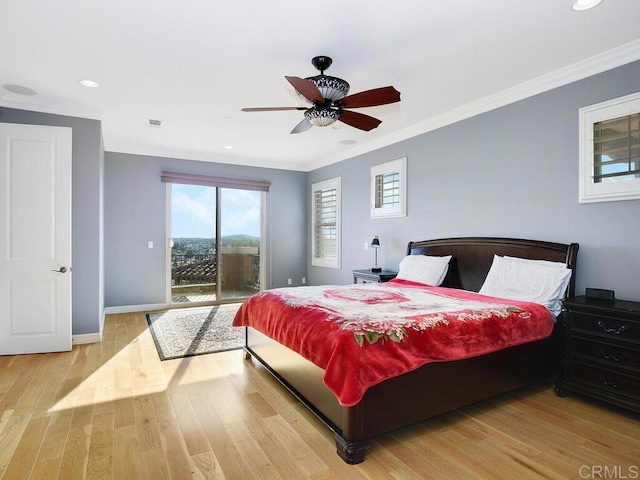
[311,177,341,268]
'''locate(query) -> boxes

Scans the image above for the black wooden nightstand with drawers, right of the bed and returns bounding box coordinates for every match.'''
[554,296,640,412]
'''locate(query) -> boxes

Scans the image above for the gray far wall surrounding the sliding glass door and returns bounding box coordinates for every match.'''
[104,152,307,307]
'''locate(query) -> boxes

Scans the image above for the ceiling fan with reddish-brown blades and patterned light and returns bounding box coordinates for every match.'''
[242,56,400,133]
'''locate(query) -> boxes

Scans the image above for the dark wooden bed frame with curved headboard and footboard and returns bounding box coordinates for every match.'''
[244,237,578,464]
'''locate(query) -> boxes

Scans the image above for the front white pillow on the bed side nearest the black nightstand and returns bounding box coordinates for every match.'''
[478,255,571,316]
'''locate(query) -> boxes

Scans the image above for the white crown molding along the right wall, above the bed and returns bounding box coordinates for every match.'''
[305,40,640,172]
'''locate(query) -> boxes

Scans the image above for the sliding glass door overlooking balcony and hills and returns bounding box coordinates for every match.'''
[168,183,262,305]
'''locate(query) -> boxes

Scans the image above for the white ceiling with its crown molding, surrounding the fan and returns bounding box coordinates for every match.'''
[0,0,640,171]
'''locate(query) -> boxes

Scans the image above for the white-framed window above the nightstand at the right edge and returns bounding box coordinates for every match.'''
[580,94,640,203]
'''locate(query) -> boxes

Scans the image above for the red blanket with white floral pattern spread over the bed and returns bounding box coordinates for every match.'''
[233,279,554,406]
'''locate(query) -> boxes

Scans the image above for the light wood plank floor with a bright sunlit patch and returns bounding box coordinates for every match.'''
[0,314,640,480]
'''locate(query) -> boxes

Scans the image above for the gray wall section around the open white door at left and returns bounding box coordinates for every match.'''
[0,107,104,335]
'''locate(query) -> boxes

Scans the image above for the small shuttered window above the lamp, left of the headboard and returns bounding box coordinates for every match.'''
[371,158,407,218]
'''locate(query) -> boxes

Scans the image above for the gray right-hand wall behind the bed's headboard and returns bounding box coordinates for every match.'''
[307,62,640,300]
